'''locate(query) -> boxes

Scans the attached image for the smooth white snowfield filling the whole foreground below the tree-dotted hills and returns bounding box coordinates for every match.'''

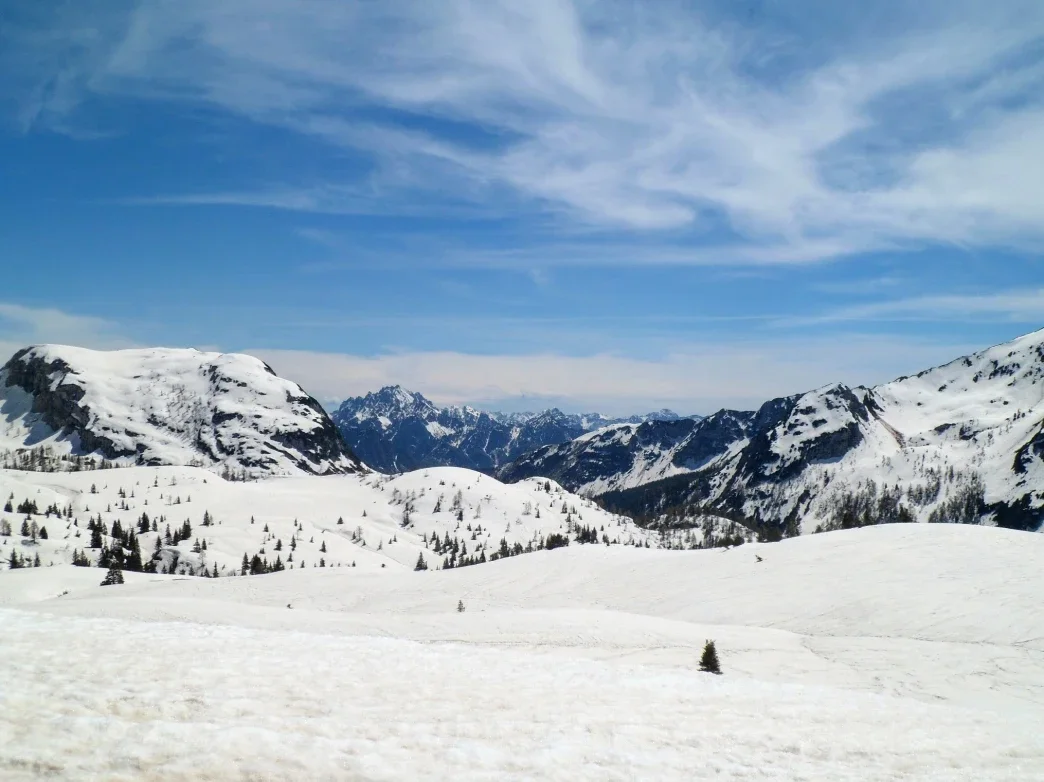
[0,496,1044,781]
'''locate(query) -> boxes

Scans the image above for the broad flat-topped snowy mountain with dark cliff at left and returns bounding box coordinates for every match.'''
[0,345,361,475]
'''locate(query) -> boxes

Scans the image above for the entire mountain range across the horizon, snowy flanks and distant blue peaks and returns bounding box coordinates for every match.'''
[0,331,1044,538]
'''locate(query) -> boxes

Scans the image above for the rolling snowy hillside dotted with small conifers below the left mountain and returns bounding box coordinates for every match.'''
[0,467,656,577]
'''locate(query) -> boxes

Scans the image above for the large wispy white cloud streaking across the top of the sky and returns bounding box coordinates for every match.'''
[7,0,1044,263]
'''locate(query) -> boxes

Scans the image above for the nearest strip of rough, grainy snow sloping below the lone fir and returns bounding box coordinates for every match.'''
[6,610,1044,781]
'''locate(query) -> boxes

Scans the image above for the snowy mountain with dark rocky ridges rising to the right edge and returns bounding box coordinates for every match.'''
[498,331,1044,535]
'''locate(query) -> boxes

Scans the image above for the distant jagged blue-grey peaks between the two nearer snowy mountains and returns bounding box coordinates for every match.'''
[332,385,679,473]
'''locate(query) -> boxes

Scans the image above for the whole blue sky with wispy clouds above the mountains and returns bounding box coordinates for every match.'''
[0,0,1044,412]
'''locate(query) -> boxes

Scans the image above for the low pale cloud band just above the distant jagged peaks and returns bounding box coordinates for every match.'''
[246,336,981,413]
